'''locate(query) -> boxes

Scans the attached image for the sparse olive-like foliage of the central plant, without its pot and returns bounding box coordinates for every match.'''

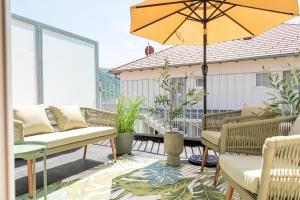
[149,59,205,133]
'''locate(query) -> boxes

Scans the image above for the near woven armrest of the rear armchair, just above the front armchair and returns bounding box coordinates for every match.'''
[222,113,278,124]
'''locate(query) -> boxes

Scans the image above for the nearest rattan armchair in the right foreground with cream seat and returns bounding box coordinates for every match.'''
[220,116,300,200]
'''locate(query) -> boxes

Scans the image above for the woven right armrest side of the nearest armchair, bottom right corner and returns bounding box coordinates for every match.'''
[258,135,300,199]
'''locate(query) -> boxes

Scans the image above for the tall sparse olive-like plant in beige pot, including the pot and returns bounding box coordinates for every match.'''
[149,60,205,167]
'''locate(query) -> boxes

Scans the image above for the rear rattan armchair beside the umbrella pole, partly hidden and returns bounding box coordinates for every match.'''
[201,110,276,186]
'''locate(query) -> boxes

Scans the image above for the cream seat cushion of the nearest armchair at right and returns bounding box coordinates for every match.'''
[219,154,262,194]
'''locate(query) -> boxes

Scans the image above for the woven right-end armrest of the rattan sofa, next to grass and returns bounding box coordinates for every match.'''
[84,108,117,127]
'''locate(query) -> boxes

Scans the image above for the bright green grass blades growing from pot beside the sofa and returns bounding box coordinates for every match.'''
[116,95,143,133]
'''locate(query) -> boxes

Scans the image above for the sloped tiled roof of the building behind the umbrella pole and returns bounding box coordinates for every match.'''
[110,24,300,74]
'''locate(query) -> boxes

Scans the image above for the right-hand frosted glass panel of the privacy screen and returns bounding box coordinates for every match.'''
[43,30,98,107]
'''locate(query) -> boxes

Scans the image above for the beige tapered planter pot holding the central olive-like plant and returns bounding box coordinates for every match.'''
[164,132,184,167]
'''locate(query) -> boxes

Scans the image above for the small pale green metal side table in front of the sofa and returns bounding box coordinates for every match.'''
[14,141,47,200]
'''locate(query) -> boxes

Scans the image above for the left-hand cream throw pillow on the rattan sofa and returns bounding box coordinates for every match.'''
[14,105,54,136]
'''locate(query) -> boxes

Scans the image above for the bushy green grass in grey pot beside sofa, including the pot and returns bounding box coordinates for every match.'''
[115,95,142,155]
